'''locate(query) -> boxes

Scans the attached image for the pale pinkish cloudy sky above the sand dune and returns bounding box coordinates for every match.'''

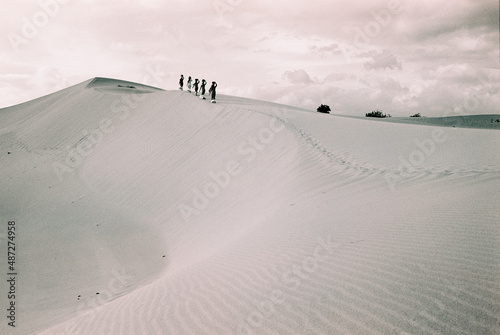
[0,0,500,116]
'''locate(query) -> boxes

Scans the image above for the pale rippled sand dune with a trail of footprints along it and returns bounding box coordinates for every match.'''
[0,78,500,335]
